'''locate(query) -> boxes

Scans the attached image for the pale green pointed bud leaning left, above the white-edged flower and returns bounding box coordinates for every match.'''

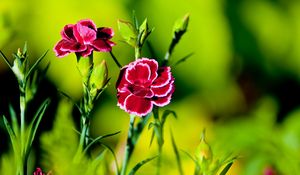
[118,20,137,47]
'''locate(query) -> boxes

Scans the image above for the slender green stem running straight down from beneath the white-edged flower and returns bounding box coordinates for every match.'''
[121,115,135,175]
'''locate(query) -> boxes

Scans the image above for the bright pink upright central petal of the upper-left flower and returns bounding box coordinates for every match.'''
[73,23,97,44]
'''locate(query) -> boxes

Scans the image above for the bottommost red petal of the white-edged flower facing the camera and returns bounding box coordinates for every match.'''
[124,94,153,116]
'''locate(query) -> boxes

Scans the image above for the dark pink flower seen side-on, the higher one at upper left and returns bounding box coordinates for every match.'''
[53,19,115,57]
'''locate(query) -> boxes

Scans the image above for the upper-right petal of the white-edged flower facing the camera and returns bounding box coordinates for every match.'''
[152,67,172,87]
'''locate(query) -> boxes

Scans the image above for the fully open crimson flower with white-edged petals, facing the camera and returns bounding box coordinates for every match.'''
[116,58,175,116]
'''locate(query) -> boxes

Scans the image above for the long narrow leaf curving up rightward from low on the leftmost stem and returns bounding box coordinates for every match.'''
[26,99,50,149]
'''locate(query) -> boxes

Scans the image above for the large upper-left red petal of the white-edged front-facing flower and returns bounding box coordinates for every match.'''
[125,63,151,85]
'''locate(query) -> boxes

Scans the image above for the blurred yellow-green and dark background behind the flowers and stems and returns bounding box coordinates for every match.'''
[0,0,300,175]
